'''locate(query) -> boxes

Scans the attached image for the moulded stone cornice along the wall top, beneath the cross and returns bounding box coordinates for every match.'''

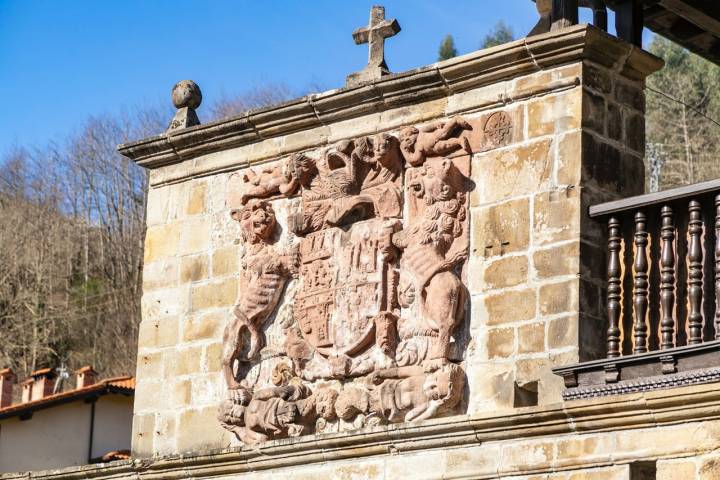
[118,25,662,169]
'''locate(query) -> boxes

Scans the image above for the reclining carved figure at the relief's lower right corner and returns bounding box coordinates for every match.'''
[368,363,464,422]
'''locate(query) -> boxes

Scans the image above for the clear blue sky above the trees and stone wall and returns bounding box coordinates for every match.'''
[0,0,628,153]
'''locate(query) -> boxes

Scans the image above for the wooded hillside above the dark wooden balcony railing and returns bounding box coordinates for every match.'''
[645,36,720,191]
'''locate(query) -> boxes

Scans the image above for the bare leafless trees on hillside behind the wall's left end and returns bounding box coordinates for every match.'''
[0,85,291,378]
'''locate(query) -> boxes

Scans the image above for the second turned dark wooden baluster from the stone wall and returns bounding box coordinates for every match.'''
[633,211,648,353]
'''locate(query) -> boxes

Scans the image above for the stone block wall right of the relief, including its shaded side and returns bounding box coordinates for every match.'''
[468,61,644,411]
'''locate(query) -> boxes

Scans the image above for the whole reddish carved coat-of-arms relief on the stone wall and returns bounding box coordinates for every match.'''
[218,111,512,444]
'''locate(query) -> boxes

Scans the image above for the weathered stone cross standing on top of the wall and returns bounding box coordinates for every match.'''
[347,5,400,86]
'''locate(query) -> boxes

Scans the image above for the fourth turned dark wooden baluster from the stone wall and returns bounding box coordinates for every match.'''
[688,200,703,345]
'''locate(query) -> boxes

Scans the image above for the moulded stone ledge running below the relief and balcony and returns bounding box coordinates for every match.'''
[7,384,720,480]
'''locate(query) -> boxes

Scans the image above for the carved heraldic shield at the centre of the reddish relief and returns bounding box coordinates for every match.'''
[294,219,392,356]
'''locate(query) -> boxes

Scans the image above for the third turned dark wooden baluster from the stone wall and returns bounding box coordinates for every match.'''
[660,205,675,349]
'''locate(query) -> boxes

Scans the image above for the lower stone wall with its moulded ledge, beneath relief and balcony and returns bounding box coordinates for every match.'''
[5,385,720,480]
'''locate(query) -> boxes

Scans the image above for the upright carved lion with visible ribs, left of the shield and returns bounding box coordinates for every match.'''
[223,199,297,390]
